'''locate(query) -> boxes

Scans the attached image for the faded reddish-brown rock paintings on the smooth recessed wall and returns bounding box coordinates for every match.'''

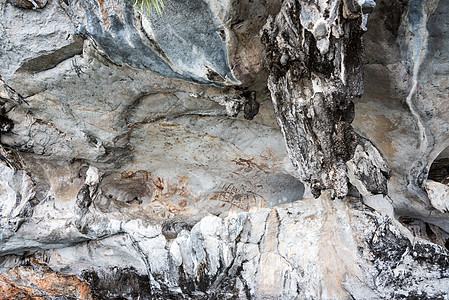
[115,162,268,219]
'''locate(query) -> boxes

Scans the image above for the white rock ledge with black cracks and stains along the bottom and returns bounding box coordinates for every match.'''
[4,194,449,299]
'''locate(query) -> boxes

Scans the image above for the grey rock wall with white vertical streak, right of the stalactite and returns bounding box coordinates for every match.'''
[353,1,449,230]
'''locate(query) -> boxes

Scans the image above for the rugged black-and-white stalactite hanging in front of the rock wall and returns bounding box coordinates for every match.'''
[262,1,388,198]
